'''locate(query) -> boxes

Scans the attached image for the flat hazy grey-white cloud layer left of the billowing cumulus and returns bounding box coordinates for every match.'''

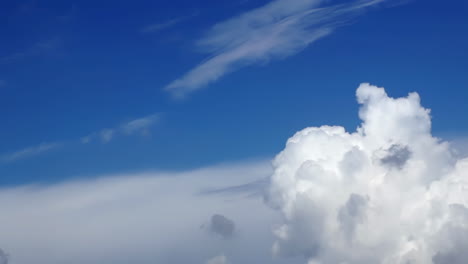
[0,161,297,264]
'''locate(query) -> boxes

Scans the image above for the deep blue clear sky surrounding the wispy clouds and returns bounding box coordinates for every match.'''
[0,0,468,185]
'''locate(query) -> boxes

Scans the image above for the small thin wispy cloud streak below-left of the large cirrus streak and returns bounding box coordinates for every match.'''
[81,113,161,143]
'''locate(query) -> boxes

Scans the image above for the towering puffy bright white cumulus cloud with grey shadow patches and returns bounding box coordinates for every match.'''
[268,84,468,264]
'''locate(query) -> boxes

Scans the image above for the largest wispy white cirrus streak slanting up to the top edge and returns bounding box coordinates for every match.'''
[164,0,385,96]
